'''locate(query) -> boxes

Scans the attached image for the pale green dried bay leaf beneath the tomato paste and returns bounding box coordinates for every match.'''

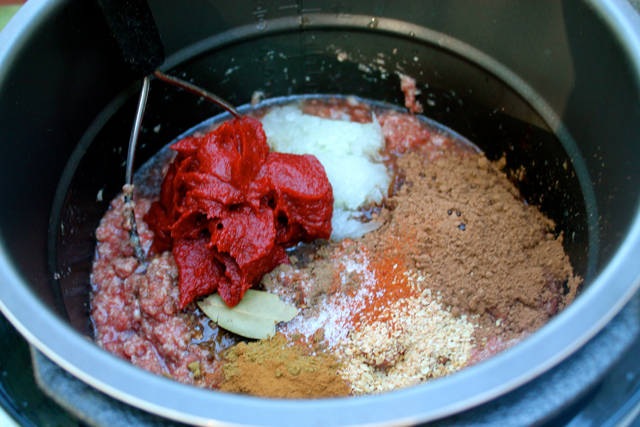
[198,289,298,339]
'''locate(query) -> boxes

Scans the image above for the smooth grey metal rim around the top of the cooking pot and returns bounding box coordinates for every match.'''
[0,0,640,426]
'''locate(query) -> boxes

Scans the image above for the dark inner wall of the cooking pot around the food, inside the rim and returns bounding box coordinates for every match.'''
[0,0,640,424]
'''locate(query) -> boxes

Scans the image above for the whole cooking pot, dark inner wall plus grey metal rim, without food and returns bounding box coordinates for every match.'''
[0,0,640,426]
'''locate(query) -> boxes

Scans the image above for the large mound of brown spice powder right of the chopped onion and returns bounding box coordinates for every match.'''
[365,153,581,341]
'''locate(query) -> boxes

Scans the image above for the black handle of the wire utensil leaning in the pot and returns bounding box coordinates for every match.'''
[95,0,164,78]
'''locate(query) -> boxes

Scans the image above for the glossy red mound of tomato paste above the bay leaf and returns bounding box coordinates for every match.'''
[144,117,333,308]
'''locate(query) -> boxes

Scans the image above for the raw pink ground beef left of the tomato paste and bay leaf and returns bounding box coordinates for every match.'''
[91,197,226,387]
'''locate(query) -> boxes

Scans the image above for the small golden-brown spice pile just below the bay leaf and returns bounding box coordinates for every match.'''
[220,334,350,399]
